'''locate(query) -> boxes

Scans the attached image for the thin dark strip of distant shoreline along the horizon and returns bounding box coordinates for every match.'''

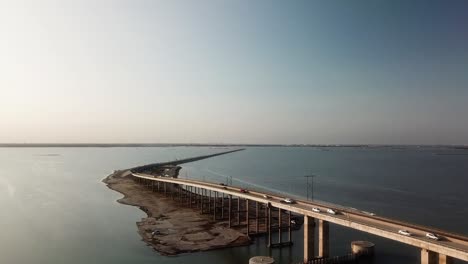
[0,143,468,150]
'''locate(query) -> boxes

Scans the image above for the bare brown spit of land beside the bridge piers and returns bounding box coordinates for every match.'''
[102,167,251,256]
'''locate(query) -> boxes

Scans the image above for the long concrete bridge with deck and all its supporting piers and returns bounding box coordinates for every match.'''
[131,170,468,264]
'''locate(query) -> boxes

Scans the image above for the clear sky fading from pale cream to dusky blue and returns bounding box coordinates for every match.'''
[0,0,468,144]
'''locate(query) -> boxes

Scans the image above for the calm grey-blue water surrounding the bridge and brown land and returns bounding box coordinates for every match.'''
[0,147,468,264]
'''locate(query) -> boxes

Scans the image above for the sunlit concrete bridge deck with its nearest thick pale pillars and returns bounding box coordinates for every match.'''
[132,173,468,264]
